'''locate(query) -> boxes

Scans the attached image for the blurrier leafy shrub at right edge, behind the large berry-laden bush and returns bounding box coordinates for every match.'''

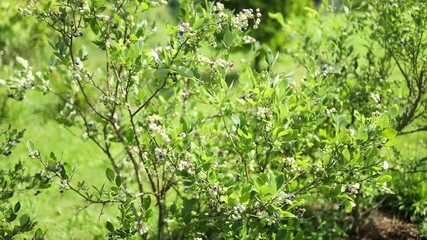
[291,1,427,236]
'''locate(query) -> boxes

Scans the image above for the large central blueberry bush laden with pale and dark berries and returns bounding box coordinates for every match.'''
[0,0,425,239]
